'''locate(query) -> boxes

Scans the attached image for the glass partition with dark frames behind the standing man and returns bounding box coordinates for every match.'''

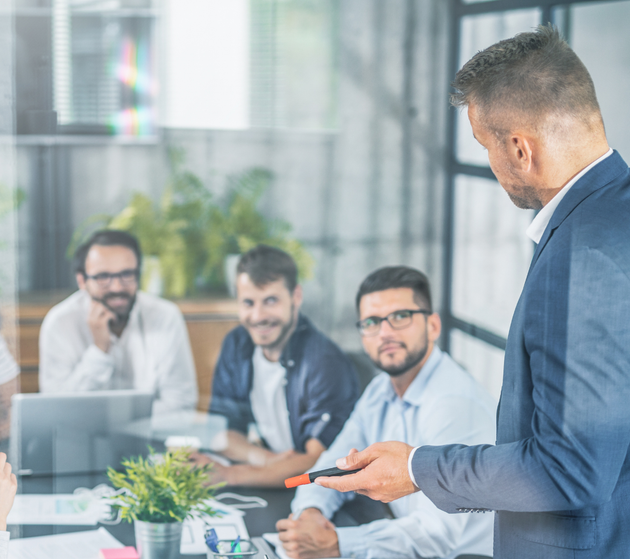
[442,0,630,397]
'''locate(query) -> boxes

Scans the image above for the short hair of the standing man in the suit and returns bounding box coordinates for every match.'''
[451,25,600,127]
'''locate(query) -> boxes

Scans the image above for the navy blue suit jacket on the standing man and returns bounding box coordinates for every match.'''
[413,152,630,559]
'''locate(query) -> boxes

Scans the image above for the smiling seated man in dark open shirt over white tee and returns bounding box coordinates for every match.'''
[196,245,359,487]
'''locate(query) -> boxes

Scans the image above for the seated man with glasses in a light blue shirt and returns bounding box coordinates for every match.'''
[276,266,496,559]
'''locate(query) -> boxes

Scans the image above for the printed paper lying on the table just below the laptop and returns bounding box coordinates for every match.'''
[7,494,108,526]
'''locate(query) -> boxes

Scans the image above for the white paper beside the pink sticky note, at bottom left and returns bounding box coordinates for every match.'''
[9,528,124,559]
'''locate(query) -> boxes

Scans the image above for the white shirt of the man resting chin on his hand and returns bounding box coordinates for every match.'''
[39,290,197,414]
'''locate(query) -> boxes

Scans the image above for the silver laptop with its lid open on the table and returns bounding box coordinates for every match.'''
[9,390,153,475]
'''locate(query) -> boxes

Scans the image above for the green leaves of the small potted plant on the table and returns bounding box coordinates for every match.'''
[107,448,223,523]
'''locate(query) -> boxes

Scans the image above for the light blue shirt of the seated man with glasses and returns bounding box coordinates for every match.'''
[291,346,496,559]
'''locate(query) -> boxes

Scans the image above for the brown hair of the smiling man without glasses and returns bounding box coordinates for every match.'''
[236,245,297,293]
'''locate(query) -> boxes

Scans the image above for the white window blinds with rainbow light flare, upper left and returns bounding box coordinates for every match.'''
[51,0,156,135]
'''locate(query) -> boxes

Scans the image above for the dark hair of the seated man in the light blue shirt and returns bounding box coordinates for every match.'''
[356,266,433,312]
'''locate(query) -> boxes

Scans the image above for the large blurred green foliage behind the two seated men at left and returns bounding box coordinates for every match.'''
[67,149,314,297]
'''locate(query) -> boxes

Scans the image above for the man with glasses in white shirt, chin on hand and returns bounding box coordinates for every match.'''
[39,230,197,414]
